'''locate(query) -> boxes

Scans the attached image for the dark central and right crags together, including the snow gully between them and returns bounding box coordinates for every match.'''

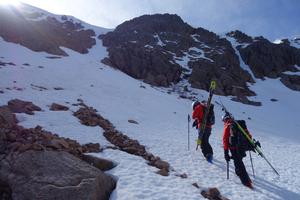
[99,14,300,101]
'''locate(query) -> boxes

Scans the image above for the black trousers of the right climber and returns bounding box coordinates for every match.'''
[230,149,251,185]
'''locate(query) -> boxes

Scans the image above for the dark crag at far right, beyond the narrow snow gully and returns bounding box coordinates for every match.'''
[227,31,300,91]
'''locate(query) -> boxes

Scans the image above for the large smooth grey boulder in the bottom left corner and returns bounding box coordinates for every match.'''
[0,150,116,200]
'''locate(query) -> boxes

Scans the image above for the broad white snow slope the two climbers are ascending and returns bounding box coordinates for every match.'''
[0,11,300,200]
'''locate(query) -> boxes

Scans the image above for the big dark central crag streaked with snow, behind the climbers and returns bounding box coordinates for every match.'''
[99,14,255,96]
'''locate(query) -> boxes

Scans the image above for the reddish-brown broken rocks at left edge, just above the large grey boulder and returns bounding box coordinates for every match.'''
[0,106,101,158]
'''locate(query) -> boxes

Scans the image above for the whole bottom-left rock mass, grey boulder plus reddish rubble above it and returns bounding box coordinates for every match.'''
[0,101,116,200]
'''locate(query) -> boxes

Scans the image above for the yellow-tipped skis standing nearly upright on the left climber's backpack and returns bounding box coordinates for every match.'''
[196,81,217,150]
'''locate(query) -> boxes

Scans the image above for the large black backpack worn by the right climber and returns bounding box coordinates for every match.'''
[229,120,254,157]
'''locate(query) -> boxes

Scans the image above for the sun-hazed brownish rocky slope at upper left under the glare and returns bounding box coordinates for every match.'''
[0,4,96,56]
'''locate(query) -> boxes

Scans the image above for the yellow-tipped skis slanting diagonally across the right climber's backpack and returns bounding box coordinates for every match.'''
[216,101,279,176]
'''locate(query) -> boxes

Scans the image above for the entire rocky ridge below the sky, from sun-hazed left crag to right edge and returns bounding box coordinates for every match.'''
[0,4,300,105]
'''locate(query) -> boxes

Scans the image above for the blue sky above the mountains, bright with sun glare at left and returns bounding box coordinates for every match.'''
[21,0,300,40]
